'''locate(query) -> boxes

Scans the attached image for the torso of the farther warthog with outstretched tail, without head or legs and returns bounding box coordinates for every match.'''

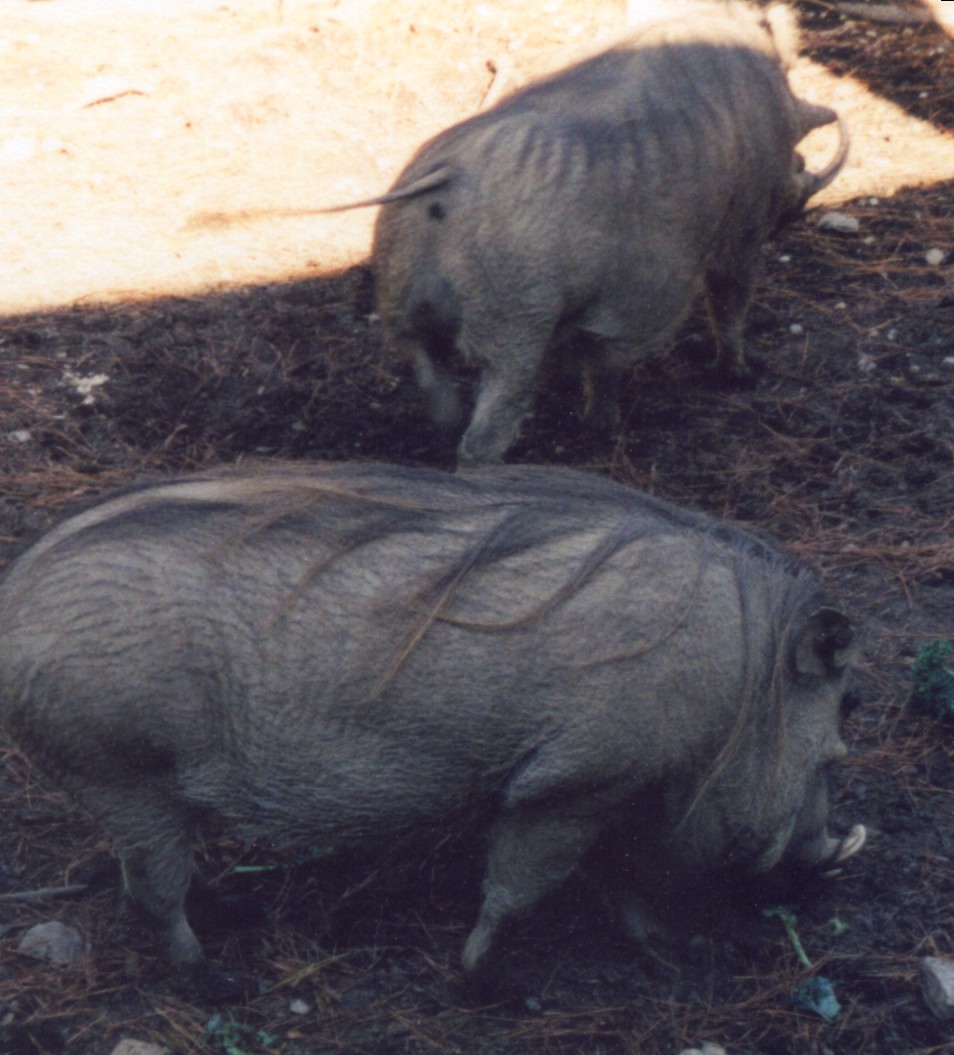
[373,13,801,359]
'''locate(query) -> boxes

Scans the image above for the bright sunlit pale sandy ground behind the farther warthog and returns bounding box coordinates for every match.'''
[0,0,954,313]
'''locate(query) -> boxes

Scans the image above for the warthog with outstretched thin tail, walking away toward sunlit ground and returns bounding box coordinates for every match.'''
[323,2,848,465]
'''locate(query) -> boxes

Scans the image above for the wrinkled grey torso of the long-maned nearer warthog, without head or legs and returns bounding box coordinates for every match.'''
[0,466,818,843]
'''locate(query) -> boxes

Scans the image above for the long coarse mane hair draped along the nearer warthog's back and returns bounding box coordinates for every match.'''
[3,463,822,824]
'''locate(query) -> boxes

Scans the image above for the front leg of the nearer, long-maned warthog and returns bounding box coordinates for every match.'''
[461,810,599,977]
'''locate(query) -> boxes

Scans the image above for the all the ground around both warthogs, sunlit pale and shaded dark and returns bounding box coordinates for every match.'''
[0,0,954,1055]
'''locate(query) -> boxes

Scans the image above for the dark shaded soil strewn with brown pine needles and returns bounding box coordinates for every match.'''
[0,4,954,1055]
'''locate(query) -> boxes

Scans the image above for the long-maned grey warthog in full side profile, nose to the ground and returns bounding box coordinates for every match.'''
[0,463,864,983]
